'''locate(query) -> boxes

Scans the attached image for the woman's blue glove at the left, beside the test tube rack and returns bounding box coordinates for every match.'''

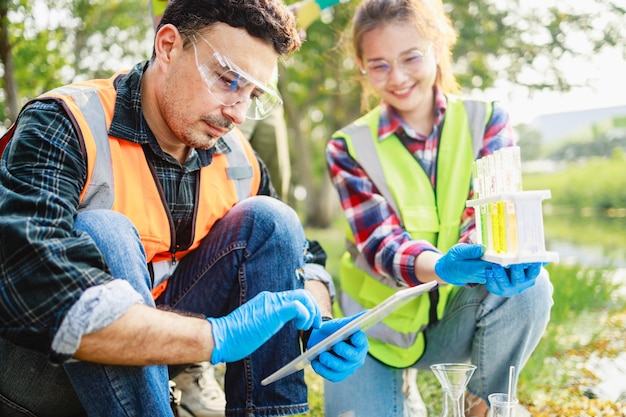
[435,243,494,286]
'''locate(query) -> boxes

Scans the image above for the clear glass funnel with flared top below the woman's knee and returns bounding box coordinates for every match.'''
[430,363,476,417]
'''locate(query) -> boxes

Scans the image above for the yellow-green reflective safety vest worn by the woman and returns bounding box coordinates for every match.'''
[333,96,492,368]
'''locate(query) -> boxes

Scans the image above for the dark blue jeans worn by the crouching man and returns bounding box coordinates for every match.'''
[0,197,308,417]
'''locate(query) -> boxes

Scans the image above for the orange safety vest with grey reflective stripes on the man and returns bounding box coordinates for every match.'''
[0,72,261,298]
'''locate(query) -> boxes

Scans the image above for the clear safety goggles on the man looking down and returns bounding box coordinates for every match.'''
[192,34,283,120]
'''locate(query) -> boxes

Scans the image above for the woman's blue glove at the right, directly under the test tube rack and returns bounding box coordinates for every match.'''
[485,263,542,297]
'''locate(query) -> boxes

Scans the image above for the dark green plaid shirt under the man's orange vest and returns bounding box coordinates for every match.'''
[0,63,276,360]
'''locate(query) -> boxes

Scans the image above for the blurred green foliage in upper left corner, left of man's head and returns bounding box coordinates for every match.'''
[0,0,152,127]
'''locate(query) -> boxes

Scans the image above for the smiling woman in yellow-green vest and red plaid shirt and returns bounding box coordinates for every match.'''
[325,0,552,417]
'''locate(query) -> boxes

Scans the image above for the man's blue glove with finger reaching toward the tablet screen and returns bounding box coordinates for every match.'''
[207,290,322,365]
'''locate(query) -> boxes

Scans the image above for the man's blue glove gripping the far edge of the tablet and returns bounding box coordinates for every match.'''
[307,311,369,382]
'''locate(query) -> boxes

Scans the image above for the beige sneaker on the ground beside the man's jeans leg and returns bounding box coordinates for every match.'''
[173,362,226,417]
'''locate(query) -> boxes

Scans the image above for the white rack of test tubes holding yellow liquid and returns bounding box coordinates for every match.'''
[466,147,559,265]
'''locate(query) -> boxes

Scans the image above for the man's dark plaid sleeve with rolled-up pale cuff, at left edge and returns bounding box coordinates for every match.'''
[0,101,136,357]
